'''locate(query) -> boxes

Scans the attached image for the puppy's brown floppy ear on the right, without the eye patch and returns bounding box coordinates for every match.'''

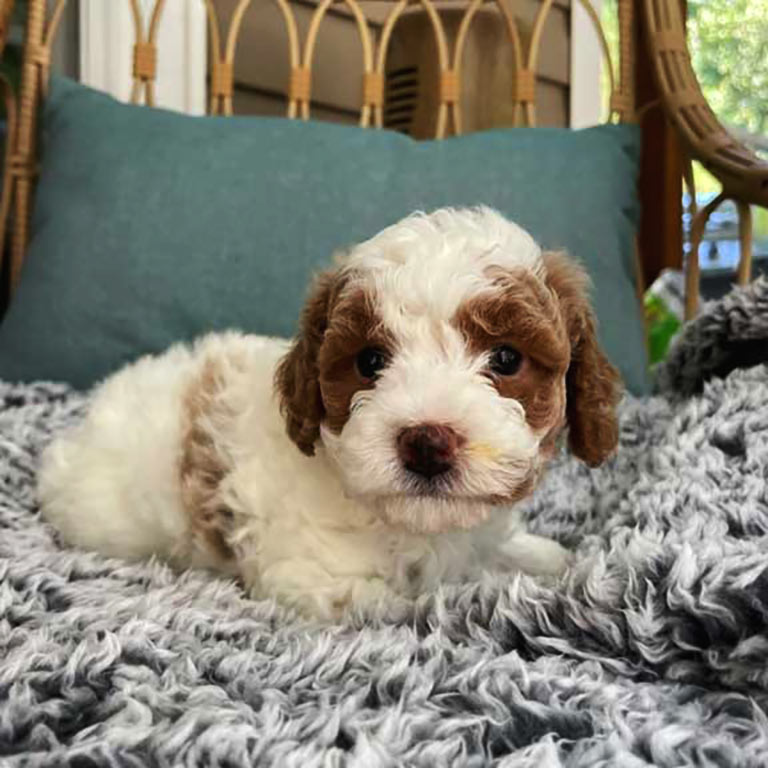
[543,253,621,467]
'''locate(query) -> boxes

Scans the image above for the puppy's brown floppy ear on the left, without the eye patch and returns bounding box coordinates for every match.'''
[275,272,340,456]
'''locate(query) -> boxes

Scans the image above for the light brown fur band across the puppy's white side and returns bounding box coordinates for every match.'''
[180,358,234,561]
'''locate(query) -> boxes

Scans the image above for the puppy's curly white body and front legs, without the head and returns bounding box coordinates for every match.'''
[40,333,566,617]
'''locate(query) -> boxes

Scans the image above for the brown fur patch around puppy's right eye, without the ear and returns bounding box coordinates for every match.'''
[455,270,569,433]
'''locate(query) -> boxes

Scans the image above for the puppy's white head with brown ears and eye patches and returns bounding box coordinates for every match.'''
[276,208,618,532]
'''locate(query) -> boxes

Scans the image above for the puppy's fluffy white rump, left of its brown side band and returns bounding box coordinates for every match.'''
[38,346,199,559]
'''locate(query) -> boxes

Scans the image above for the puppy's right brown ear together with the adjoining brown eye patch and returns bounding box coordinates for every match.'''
[456,253,620,466]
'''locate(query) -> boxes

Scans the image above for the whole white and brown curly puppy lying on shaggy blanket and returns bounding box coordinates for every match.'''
[39,208,618,617]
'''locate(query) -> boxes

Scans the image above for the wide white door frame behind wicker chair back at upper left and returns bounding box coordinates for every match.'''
[80,0,207,115]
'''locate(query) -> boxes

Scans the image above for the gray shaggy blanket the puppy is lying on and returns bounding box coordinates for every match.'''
[0,282,768,768]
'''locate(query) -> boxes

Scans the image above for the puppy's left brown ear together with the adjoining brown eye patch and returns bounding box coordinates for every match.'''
[275,272,391,456]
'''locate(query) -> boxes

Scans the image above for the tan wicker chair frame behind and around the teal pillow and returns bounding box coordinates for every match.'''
[0,0,768,316]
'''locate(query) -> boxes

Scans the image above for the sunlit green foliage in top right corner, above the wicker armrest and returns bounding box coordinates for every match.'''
[688,0,768,134]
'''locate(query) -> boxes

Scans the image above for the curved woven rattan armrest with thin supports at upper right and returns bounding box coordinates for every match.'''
[644,0,768,317]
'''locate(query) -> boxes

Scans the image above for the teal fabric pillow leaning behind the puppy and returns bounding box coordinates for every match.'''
[0,79,647,393]
